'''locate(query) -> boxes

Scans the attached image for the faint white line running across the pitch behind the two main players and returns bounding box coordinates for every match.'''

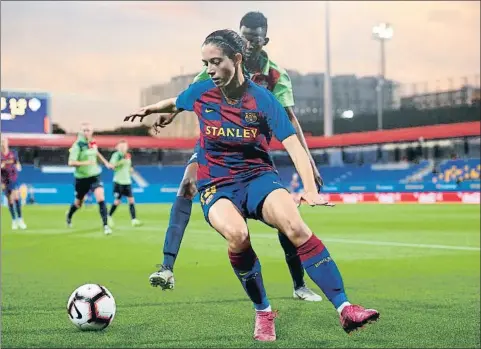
[5,226,481,252]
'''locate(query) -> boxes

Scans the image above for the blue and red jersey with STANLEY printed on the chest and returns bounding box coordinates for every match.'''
[176,79,296,190]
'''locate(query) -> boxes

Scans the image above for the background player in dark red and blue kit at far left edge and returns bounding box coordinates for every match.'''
[1,137,27,230]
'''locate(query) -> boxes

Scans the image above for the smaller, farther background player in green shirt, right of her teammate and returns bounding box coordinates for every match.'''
[107,140,140,227]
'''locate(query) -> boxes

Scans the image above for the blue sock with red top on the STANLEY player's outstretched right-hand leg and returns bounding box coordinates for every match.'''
[297,234,348,310]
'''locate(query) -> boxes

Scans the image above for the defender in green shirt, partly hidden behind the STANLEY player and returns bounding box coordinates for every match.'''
[142,12,322,301]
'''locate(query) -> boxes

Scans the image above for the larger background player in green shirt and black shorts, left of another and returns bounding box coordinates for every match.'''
[67,122,113,234]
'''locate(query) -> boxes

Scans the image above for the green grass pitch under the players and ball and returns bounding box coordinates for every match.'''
[1,204,480,348]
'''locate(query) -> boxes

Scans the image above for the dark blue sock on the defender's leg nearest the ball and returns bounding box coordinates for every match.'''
[162,196,192,270]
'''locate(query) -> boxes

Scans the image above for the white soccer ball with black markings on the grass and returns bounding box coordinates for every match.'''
[67,284,116,331]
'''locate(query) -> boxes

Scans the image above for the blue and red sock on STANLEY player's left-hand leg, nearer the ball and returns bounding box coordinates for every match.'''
[228,245,270,311]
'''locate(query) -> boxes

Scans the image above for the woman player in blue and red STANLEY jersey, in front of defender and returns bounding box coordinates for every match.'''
[130,30,379,341]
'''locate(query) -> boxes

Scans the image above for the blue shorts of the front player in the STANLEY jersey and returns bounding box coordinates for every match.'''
[200,172,287,224]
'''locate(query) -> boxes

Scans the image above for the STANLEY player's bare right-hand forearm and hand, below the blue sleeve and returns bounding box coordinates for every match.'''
[282,135,333,206]
